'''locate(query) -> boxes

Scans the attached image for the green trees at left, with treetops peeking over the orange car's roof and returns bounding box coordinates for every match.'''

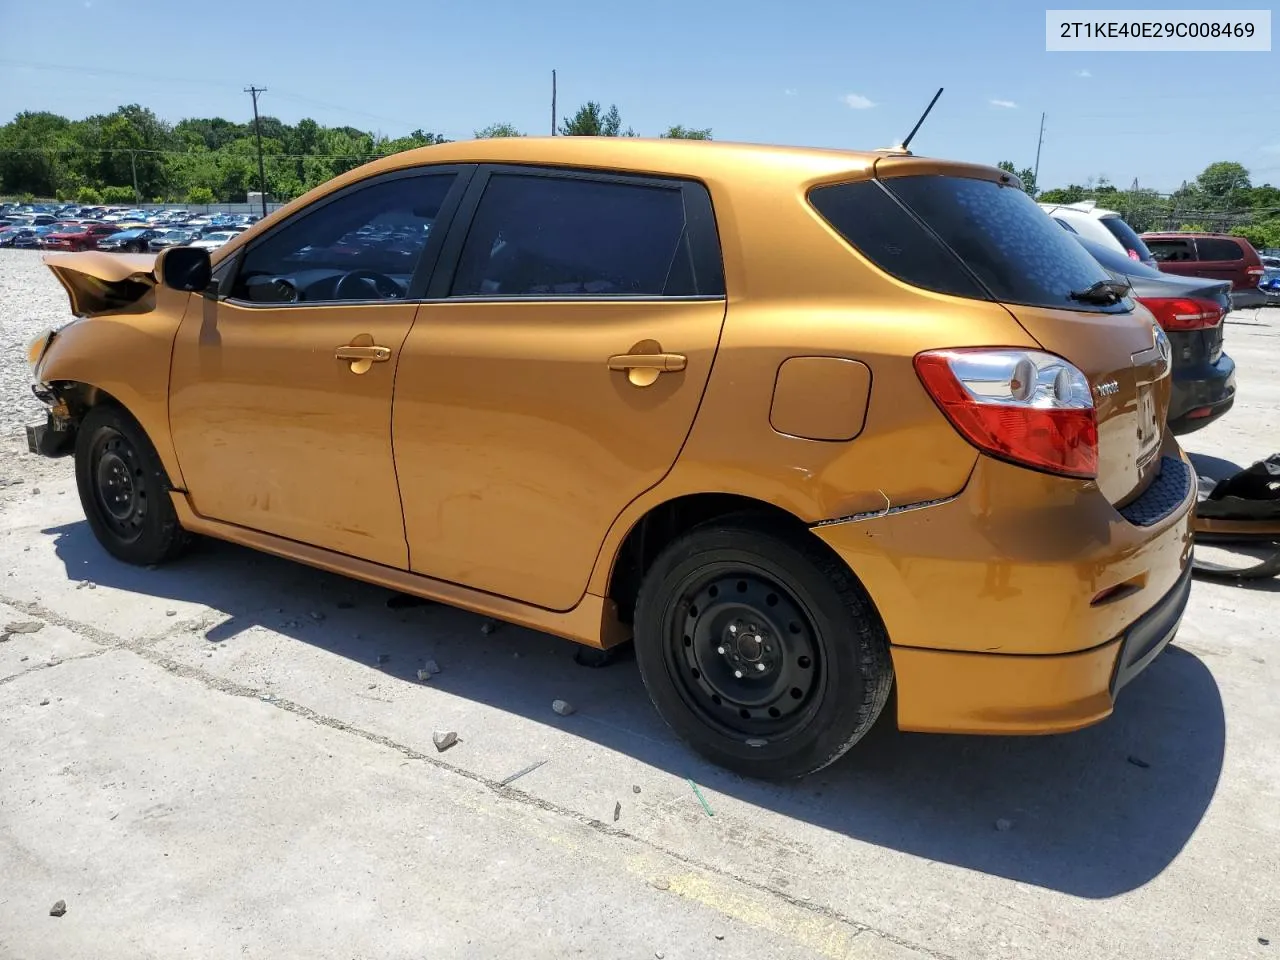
[0,101,712,204]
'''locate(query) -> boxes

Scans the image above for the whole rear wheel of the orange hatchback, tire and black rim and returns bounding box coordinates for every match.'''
[635,517,893,780]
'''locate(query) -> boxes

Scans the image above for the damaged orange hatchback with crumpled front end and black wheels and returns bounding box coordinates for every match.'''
[28,137,1194,777]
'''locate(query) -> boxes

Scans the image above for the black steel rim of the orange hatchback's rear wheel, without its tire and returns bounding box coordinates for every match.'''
[667,568,823,740]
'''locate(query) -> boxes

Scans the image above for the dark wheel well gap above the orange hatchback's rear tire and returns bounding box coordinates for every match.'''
[608,493,805,623]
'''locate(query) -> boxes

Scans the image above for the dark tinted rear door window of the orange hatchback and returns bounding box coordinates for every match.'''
[449,173,724,298]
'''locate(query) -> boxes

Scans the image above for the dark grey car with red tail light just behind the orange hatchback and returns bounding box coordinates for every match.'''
[1076,237,1235,434]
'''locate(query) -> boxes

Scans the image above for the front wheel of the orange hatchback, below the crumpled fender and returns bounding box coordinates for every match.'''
[76,404,189,566]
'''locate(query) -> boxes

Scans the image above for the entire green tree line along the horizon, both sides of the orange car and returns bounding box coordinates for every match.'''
[0,100,1280,248]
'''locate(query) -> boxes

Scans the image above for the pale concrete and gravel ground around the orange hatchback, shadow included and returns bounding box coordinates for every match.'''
[0,251,1280,960]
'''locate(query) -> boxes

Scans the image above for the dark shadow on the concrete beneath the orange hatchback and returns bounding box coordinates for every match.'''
[44,522,1225,899]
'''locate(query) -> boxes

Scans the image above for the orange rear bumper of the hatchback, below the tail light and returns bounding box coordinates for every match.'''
[814,443,1196,733]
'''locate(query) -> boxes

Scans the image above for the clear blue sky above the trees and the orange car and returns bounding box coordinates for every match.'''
[0,0,1280,189]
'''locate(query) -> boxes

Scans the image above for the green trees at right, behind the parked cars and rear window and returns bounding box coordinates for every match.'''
[1000,160,1280,250]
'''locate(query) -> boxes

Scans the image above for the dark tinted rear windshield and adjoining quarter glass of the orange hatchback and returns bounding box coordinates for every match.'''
[809,175,1132,312]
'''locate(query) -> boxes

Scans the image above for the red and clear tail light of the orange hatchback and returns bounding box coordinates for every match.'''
[915,347,1098,479]
